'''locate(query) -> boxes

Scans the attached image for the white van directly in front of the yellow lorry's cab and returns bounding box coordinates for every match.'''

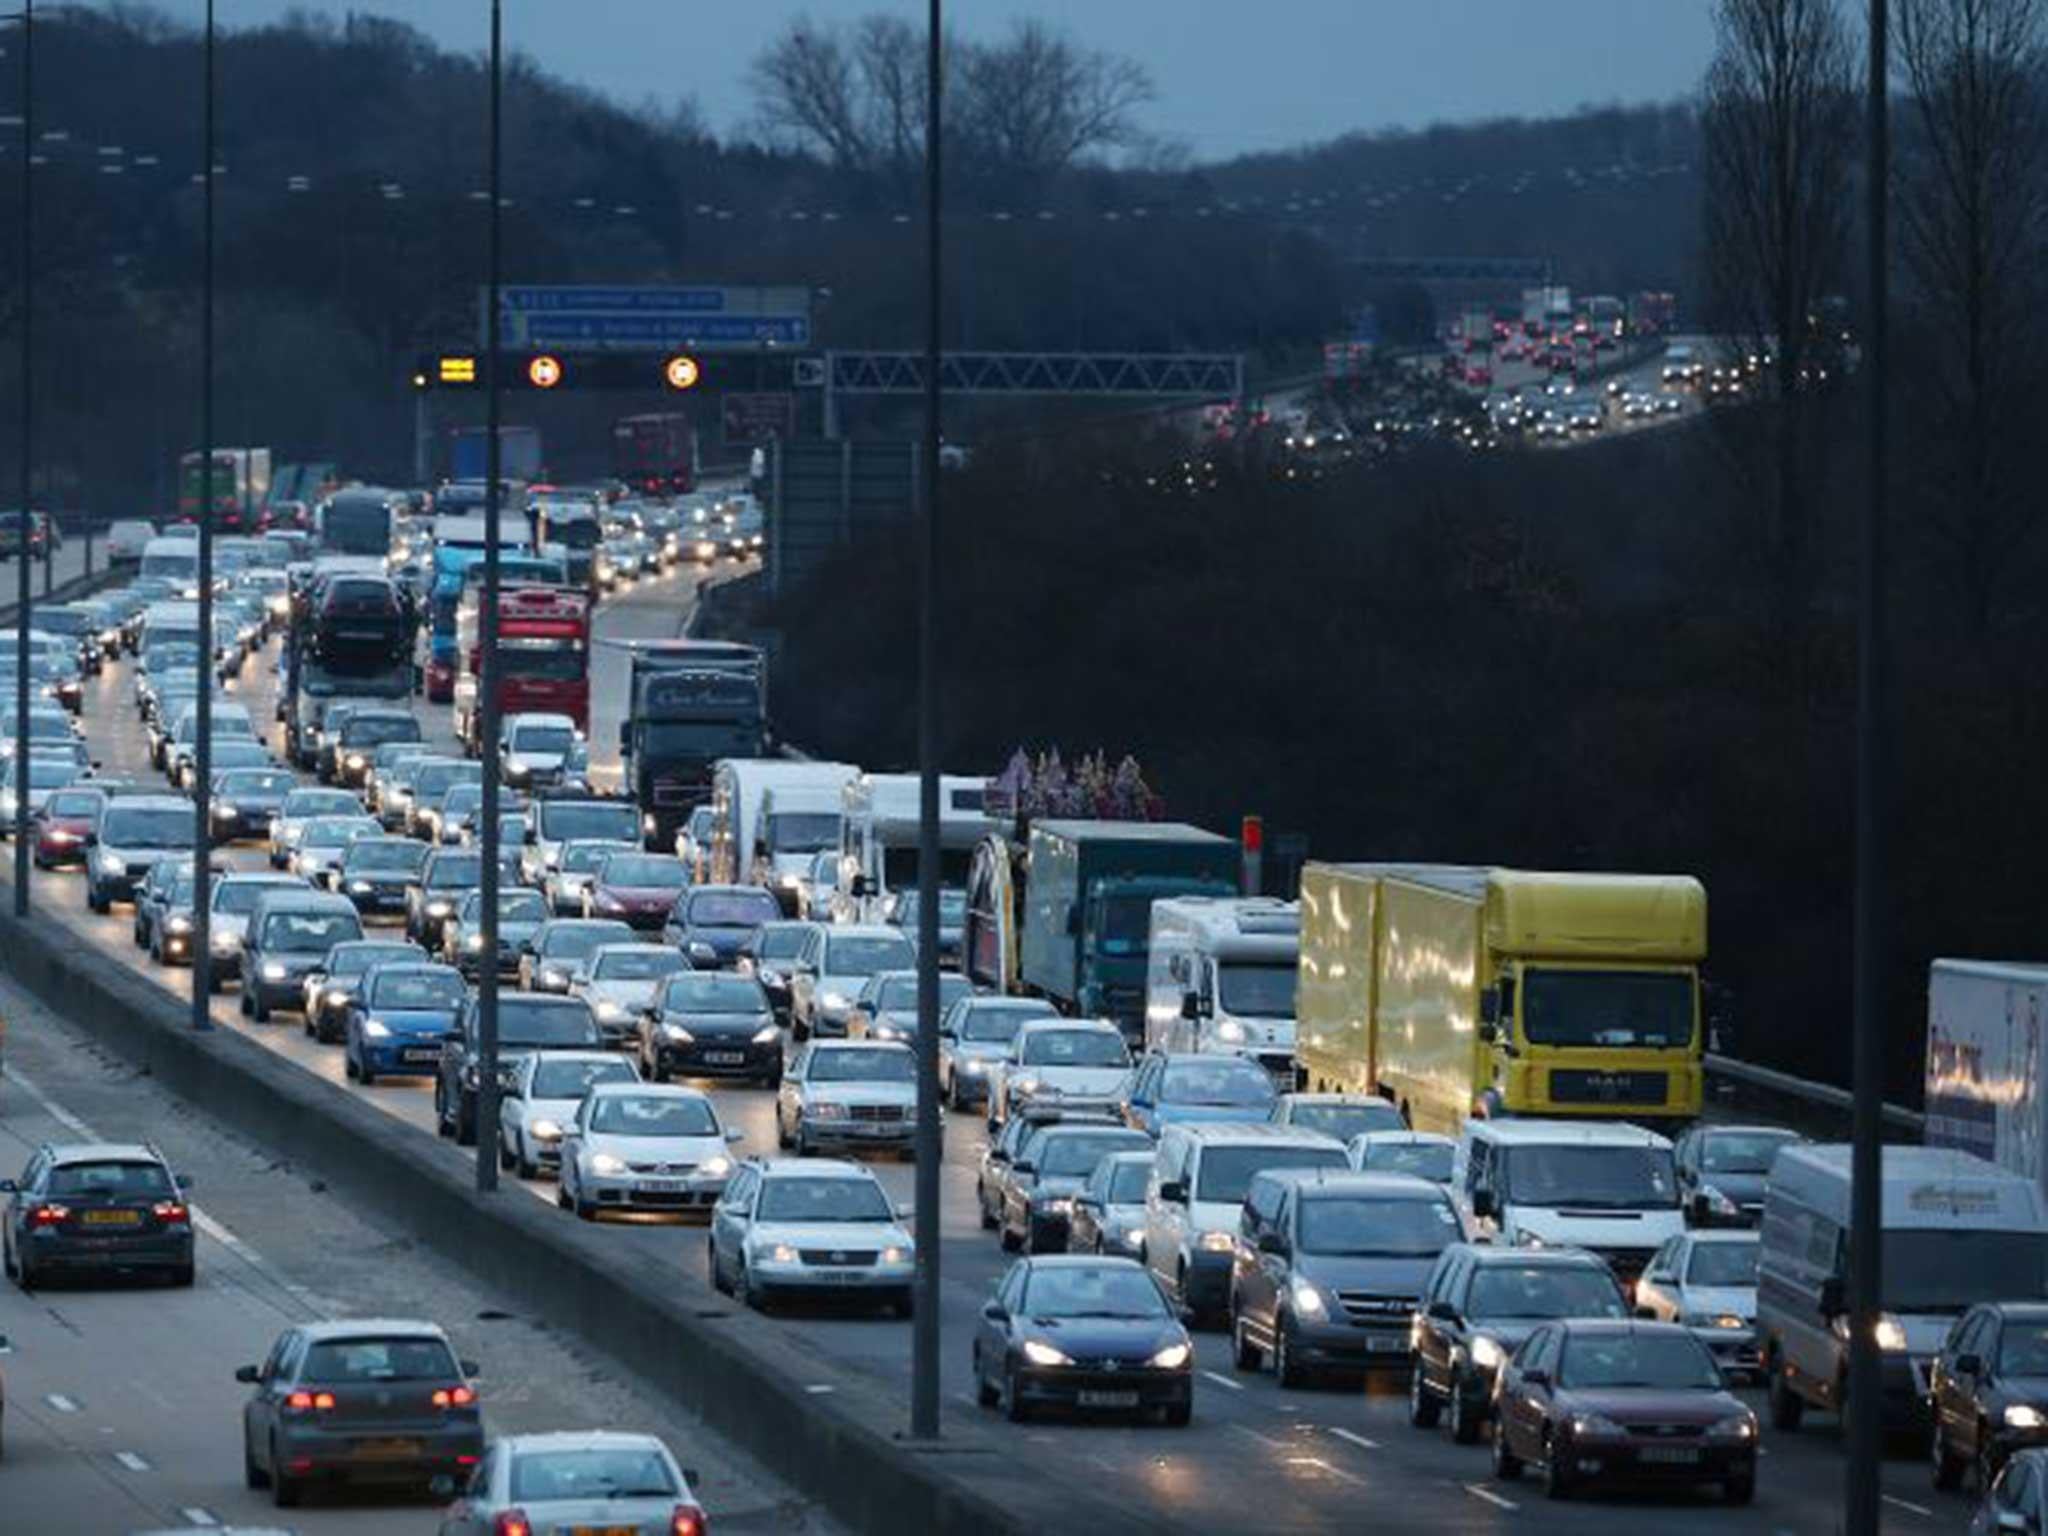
[1450,1120,1686,1288]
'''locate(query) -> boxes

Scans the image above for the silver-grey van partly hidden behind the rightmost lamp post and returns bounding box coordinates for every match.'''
[1757,1145,2048,1430]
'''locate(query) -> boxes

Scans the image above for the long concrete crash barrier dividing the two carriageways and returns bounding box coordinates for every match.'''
[0,883,1146,1534]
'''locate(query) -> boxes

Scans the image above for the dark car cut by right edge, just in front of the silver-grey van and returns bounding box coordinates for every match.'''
[1927,1300,2048,1489]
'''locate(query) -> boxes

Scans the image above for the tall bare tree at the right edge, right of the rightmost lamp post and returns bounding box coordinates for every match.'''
[1894,0,2048,627]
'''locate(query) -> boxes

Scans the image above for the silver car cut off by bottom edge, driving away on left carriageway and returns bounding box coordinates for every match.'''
[440,1432,707,1536]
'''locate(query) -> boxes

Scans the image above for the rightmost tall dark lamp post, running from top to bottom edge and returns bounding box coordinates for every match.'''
[1843,0,1890,1536]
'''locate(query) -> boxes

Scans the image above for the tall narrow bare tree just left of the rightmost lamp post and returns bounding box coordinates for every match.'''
[1700,0,1855,623]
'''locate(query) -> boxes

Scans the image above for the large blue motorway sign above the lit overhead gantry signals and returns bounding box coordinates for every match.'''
[477,285,811,352]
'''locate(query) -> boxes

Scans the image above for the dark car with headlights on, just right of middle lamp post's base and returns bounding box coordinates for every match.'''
[973,1253,1194,1427]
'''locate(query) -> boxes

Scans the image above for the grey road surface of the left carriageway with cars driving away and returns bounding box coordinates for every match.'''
[0,981,829,1536]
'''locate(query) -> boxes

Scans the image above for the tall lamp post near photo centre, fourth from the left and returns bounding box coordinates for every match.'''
[909,0,944,1440]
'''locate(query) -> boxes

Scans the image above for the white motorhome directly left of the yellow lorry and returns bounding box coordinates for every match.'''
[1145,897,1300,1087]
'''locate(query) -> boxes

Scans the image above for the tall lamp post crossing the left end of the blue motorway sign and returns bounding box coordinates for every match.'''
[475,0,504,1194]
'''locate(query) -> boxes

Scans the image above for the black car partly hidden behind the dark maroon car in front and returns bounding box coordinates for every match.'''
[1409,1243,1628,1444]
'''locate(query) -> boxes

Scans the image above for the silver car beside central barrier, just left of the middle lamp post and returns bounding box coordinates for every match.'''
[709,1159,918,1317]
